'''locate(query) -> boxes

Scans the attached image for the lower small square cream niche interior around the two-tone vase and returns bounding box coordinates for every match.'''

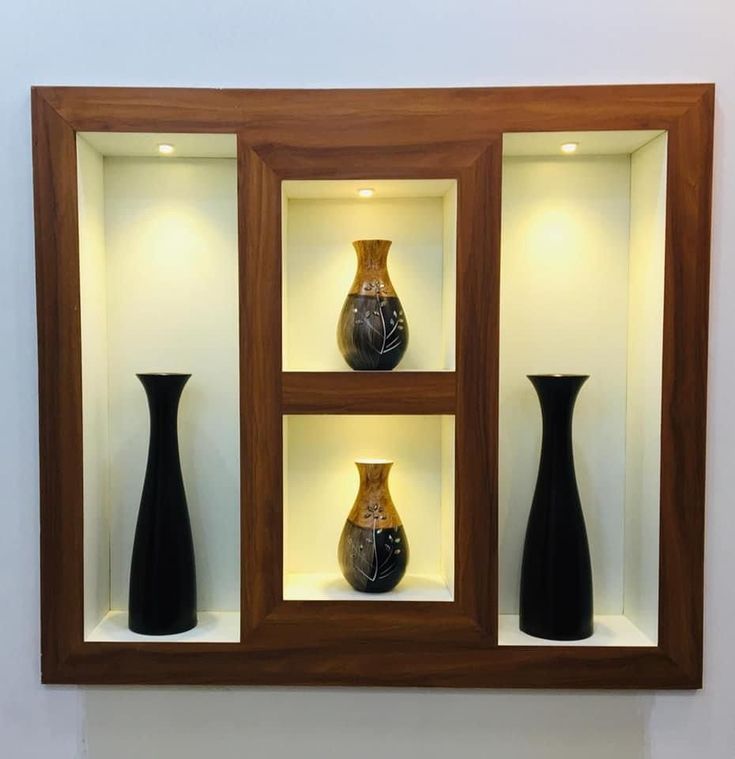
[283,415,454,601]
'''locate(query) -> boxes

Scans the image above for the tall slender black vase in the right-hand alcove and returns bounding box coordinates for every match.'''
[520,374,593,640]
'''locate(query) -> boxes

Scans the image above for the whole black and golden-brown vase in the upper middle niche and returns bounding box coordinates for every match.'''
[337,240,408,370]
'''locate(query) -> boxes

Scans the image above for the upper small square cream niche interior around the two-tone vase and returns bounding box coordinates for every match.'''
[282,178,457,378]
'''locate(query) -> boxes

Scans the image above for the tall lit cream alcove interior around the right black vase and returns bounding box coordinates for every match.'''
[499,131,667,646]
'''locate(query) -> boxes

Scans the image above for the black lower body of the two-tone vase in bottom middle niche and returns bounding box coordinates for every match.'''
[338,519,409,593]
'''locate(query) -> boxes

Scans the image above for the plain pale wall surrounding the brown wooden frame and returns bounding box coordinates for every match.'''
[0,0,735,759]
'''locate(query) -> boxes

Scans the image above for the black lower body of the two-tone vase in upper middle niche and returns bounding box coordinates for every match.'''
[337,294,408,370]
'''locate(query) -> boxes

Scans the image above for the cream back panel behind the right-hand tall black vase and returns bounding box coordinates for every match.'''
[499,156,630,614]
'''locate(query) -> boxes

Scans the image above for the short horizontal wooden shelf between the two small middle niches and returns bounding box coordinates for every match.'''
[282,371,456,414]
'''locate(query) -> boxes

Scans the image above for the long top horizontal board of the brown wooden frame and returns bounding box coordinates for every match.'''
[39,84,711,140]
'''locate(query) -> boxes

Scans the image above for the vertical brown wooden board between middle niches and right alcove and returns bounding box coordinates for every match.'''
[455,140,502,642]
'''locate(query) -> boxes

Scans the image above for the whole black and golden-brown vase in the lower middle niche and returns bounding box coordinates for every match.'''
[337,460,408,593]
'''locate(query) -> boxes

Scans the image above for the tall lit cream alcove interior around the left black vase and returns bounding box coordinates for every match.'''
[77,132,240,642]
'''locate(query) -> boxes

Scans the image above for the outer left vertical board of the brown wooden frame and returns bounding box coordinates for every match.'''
[32,94,84,682]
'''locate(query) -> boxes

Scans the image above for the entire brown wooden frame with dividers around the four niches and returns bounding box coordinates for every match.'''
[32,85,714,688]
